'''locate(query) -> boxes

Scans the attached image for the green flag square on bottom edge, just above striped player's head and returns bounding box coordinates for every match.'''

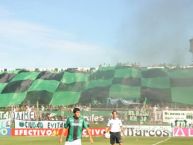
[50,91,80,106]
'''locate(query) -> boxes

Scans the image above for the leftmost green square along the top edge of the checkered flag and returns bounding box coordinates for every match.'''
[11,72,39,81]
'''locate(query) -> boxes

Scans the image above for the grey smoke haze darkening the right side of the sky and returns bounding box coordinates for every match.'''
[118,0,193,65]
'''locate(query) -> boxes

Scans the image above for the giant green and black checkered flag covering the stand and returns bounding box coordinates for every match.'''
[0,65,193,106]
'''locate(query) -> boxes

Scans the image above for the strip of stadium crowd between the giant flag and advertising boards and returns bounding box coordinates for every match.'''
[0,104,193,127]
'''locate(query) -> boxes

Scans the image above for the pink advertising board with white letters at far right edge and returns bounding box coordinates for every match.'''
[173,128,193,137]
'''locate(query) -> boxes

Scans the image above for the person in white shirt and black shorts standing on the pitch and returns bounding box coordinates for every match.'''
[104,110,122,145]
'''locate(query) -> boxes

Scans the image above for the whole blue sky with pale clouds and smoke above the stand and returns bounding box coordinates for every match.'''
[0,0,193,69]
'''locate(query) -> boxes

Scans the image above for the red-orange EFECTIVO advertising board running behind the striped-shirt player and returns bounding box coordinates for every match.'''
[11,128,105,137]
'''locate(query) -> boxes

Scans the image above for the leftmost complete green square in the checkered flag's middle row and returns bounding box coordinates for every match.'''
[29,79,59,92]
